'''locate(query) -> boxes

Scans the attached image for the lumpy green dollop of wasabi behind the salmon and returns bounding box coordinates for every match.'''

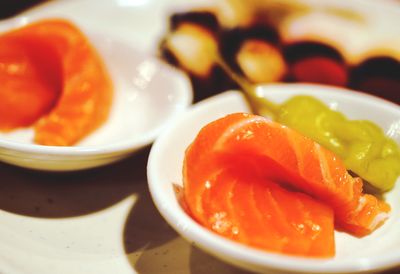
[275,96,400,192]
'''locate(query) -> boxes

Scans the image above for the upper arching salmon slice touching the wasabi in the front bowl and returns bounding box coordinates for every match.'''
[183,113,390,250]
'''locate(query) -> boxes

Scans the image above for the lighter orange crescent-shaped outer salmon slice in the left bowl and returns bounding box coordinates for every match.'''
[3,19,112,146]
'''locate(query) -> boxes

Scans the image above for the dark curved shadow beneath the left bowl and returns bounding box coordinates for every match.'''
[0,148,149,218]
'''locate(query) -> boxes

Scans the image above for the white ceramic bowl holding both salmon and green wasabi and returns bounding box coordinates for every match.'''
[147,84,400,273]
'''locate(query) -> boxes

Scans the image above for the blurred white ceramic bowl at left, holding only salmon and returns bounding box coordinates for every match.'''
[0,17,192,171]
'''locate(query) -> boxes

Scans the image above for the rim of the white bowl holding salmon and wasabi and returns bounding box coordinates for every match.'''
[147,83,400,273]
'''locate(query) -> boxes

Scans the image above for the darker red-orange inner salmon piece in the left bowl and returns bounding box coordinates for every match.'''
[0,36,61,131]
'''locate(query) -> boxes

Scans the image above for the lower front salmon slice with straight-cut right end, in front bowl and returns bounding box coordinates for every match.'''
[197,166,335,257]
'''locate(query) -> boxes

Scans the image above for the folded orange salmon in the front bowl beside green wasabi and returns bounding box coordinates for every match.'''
[183,113,390,257]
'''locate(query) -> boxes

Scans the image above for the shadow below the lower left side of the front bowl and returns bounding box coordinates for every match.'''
[123,182,252,274]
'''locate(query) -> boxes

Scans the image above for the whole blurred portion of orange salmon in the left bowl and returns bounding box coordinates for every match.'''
[0,19,113,146]
